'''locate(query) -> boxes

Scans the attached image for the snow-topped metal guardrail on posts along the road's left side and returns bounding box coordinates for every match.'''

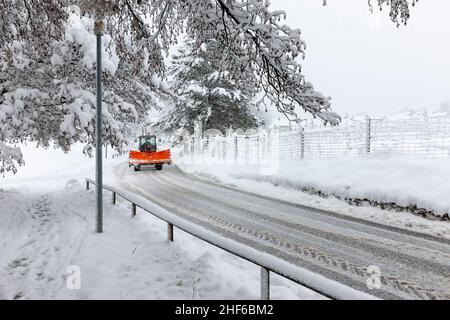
[86,179,378,300]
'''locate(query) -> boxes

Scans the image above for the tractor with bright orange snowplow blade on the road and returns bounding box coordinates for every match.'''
[128,136,172,171]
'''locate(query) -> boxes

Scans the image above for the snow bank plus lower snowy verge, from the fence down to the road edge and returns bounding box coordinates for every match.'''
[175,153,450,239]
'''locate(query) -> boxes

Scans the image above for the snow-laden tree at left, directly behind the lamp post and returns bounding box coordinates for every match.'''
[0,7,170,171]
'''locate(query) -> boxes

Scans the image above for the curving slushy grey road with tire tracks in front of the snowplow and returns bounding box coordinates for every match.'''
[114,164,450,299]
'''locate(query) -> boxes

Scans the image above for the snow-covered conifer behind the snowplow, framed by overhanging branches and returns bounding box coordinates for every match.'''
[155,40,257,133]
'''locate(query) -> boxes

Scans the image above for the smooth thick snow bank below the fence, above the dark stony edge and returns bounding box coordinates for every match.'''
[181,154,450,217]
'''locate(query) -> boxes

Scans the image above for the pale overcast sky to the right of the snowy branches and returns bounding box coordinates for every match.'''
[271,0,450,115]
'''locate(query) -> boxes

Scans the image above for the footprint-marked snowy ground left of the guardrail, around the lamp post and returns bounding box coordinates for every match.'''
[0,146,320,299]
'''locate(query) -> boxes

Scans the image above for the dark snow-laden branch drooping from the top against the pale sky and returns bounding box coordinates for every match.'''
[208,0,339,123]
